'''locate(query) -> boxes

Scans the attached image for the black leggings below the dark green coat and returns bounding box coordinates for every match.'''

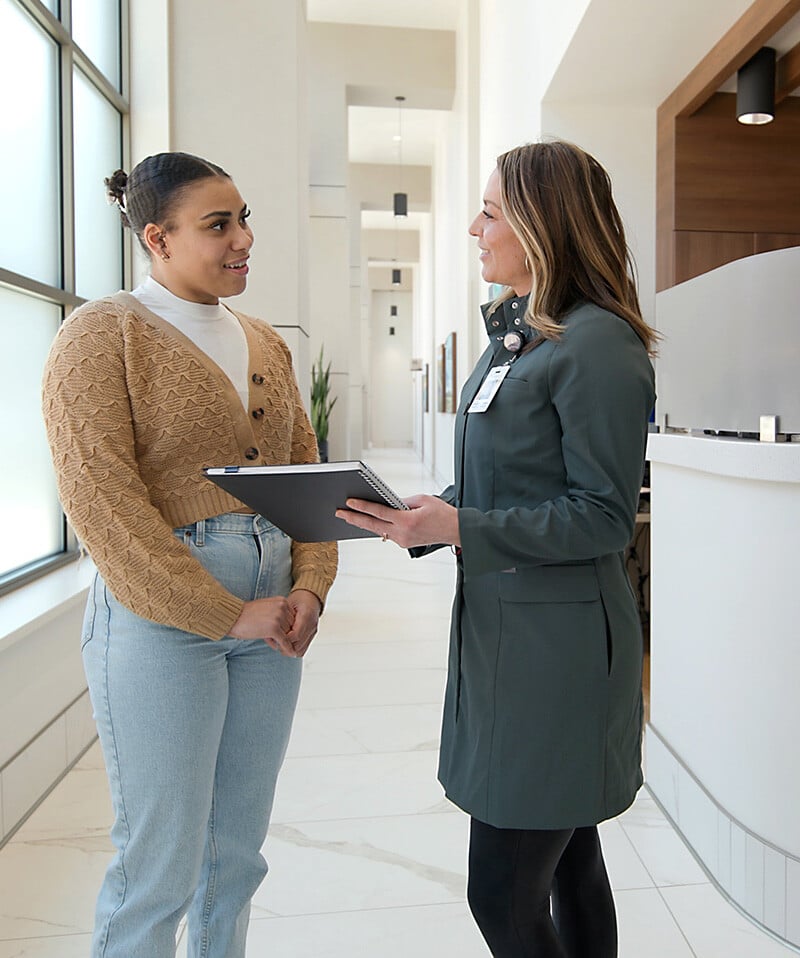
[467,818,617,958]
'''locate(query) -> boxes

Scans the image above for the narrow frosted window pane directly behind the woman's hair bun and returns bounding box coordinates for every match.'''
[73,70,122,299]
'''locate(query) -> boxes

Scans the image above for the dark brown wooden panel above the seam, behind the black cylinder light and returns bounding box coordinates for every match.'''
[675,93,800,233]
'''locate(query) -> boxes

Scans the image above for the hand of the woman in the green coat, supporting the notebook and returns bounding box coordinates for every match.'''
[336,496,461,549]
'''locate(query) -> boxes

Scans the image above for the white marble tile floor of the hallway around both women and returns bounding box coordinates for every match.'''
[0,451,796,958]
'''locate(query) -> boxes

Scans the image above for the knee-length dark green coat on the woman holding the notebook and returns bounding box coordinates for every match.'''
[432,299,655,829]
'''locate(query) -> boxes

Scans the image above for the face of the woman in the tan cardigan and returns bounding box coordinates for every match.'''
[144,176,253,304]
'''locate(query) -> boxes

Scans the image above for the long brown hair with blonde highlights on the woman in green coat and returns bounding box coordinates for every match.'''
[491,140,659,356]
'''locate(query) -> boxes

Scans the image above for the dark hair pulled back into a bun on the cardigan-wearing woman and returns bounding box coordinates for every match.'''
[104,153,230,255]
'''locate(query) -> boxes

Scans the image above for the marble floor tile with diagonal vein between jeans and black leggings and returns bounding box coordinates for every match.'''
[253,812,469,917]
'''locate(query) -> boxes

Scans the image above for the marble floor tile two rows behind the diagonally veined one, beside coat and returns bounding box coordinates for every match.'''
[287,704,442,757]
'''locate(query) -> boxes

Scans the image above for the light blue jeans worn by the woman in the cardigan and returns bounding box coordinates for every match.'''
[82,514,301,958]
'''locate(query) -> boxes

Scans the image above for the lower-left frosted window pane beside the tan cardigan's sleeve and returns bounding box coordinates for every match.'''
[0,287,64,575]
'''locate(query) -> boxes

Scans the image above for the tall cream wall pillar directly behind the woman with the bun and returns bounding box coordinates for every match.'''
[170,0,310,384]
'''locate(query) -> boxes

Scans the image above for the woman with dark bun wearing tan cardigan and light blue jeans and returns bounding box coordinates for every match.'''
[43,153,337,958]
